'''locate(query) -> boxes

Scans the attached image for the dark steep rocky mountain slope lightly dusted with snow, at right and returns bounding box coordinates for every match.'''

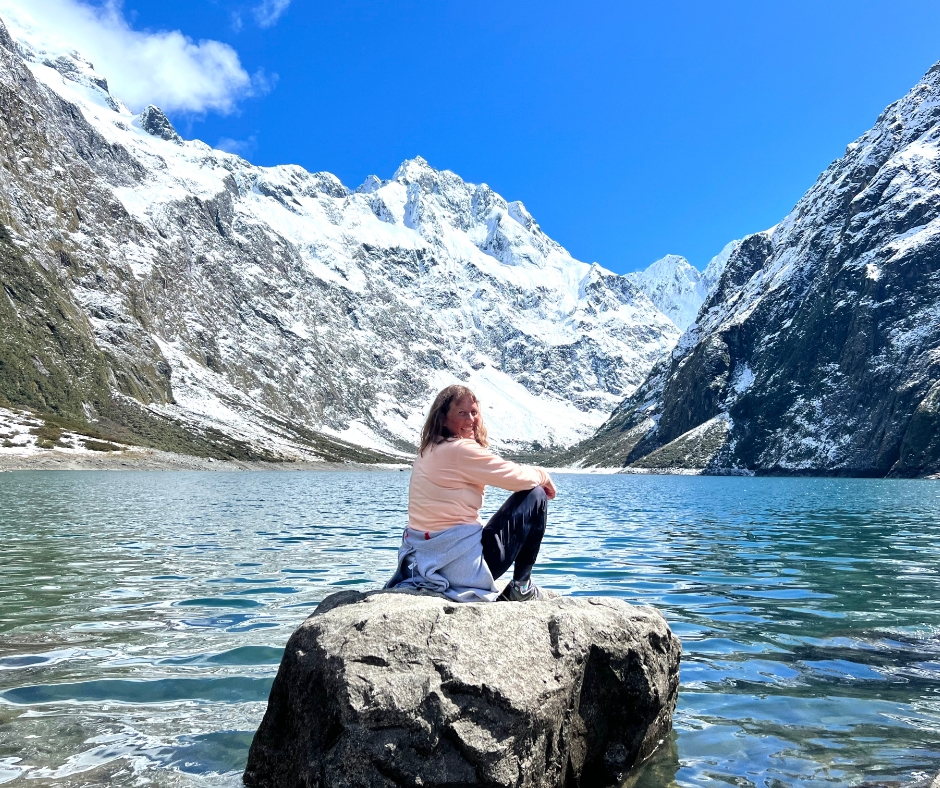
[569,64,940,476]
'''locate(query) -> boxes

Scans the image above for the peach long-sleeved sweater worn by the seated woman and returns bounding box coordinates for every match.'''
[408,438,549,533]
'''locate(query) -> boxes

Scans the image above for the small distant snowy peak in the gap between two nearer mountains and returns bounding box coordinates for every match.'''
[627,246,739,331]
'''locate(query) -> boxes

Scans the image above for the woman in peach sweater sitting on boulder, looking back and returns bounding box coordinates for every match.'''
[385,386,555,602]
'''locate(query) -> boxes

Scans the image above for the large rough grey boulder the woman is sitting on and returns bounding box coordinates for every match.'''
[244,591,682,788]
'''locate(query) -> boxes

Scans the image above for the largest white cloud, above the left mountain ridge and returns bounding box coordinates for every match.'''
[0,0,268,113]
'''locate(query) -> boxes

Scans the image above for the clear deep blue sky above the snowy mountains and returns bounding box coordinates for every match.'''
[6,0,940,272]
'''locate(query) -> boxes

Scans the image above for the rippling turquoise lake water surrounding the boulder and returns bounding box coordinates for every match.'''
[0,472,940,788]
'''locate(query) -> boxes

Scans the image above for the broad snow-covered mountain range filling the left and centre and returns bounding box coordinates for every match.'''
[0,13,680,457]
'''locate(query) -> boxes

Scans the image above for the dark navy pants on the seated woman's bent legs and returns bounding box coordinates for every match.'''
[481,487,548,582]
